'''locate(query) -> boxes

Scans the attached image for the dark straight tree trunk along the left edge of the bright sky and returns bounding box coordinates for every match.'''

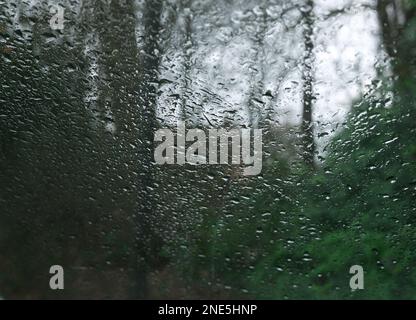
[137,0,165,296]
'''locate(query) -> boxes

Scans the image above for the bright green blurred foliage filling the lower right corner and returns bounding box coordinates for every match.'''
[170,10,416,299]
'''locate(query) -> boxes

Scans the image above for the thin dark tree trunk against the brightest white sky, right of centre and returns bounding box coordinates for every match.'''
[302,0,316,166]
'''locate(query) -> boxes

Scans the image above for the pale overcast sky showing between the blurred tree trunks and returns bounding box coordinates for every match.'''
[4,0,379,155]
